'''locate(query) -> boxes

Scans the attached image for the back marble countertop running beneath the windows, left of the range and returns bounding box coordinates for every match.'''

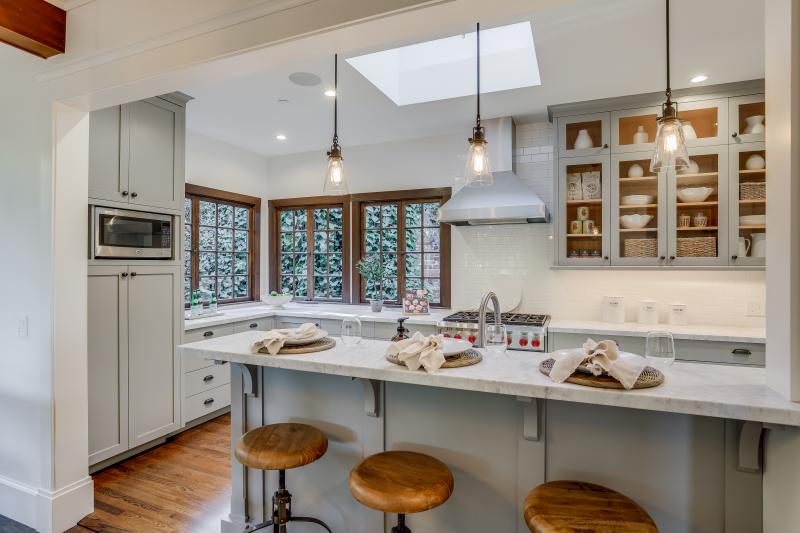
[183,303,453,331]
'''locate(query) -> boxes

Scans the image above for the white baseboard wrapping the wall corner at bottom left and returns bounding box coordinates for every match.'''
[0,476,94,533]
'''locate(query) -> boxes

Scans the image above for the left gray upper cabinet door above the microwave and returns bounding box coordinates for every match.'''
[89,106,128,202]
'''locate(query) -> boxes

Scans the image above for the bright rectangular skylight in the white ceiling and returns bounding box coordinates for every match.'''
[347,21,542,106]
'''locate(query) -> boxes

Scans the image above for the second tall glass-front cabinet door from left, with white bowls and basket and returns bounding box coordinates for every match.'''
[611,152,667,266]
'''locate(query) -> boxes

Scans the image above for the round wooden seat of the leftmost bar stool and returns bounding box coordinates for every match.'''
[236,423,328,470]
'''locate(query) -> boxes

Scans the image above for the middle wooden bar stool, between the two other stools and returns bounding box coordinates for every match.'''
[350,452,453,533]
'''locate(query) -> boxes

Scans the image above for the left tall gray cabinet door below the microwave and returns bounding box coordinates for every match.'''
[87,266,128,464]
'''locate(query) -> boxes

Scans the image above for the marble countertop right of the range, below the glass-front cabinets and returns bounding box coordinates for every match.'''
[548,319,767,344]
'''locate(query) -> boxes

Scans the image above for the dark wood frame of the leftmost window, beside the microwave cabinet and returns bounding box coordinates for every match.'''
[181,183,261,307]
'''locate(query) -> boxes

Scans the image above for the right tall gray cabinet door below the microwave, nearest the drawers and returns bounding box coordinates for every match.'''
[128,265,182,448]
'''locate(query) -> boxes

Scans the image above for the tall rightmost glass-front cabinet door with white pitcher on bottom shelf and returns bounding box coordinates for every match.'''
[728,143,767,266]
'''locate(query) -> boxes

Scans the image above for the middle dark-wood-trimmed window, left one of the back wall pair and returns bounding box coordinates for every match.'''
[269,196,350,303]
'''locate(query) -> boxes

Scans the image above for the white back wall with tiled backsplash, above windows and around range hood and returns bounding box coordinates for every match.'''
[267,123,765,327]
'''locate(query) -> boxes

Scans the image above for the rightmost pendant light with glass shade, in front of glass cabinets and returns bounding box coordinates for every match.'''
[650,0,689,172]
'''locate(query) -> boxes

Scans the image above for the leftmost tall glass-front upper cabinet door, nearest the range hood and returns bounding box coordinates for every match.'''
[558,155,611,266]
